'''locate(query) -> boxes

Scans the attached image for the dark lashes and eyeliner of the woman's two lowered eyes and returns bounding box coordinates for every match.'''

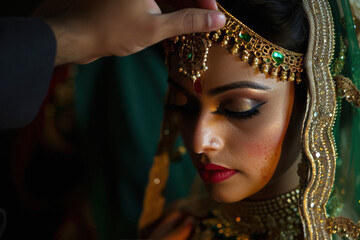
[165,102,266,119]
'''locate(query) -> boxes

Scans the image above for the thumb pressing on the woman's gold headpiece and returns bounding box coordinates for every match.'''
[157,8,226,40]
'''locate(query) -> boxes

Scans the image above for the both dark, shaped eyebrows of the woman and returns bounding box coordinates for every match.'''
[167,77,271,96]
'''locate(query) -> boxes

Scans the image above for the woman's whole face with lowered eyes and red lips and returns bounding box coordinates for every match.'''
[168,45,294,202]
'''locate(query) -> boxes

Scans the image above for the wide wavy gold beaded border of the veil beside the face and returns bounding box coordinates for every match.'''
[300,0,336,240]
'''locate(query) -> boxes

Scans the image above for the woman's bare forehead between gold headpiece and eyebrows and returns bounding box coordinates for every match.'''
[170,44,290,91]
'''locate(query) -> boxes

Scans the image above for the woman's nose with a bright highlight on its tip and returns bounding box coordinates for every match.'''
[192,113,224,154]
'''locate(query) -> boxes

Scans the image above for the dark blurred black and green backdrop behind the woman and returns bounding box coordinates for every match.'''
[0,0,195,240]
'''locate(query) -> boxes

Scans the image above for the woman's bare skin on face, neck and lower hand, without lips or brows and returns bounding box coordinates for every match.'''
[150,45,306,239]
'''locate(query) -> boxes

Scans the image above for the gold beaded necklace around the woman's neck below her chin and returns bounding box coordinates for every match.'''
[193,189,303,240]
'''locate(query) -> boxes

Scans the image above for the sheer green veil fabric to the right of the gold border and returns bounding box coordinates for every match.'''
[327,0,360,234]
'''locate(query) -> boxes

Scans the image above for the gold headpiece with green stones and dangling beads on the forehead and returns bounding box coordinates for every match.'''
[168,4,304,93]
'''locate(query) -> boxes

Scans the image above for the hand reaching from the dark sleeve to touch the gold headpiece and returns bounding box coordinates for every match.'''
[35,0,225,65]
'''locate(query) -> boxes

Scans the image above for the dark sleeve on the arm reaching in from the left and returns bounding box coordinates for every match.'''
[0,18,56,129]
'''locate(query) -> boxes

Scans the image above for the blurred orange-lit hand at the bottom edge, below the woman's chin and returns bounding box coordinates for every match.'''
[149,212,194,240]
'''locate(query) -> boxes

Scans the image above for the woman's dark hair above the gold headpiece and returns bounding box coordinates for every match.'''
[218,0,309,53]
